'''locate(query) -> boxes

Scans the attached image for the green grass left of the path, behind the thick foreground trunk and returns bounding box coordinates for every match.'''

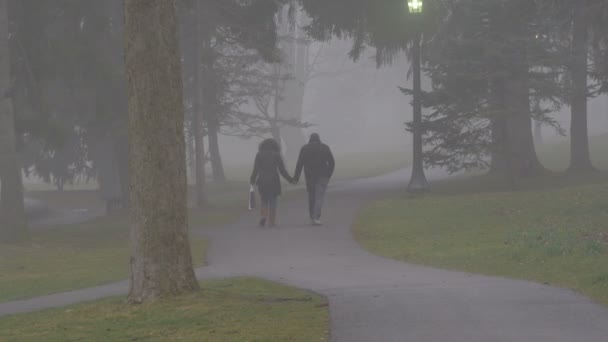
[0,176,284,302]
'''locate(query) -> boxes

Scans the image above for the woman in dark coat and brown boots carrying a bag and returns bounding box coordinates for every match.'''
[251,139,294,227]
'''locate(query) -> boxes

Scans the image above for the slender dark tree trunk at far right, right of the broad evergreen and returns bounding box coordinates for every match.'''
[569,1,593,172]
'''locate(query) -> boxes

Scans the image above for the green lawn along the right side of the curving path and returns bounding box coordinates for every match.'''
[355,182,608,304]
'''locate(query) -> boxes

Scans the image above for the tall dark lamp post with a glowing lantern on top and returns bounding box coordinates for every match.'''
[407,0,430,193]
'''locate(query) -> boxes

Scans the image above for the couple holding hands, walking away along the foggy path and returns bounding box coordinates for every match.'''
[251,133,335,227]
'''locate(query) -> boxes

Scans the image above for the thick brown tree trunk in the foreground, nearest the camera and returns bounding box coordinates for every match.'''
[124,0,199,303]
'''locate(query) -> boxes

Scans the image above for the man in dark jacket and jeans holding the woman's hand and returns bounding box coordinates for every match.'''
[294,133,335,225]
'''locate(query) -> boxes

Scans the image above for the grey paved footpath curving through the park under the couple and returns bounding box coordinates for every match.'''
[0,170,608,342]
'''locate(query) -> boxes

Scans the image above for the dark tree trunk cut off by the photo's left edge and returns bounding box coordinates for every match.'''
[0,0,27,242]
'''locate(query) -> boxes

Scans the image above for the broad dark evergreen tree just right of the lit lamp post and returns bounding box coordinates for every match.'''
[408,0,561,182]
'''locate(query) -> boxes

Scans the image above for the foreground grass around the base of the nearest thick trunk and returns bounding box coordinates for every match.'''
[0,279,329,342]
